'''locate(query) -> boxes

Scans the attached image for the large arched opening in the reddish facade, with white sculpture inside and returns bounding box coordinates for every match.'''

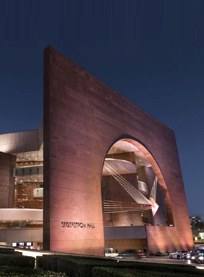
[102,138,174,251]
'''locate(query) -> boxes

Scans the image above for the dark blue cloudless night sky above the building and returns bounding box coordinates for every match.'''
[0,0,204,218]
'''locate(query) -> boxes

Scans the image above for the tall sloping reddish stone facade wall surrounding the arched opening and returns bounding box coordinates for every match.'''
[43,47,193,255]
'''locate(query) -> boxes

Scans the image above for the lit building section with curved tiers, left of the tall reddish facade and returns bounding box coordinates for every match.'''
[0,128,43,248]
